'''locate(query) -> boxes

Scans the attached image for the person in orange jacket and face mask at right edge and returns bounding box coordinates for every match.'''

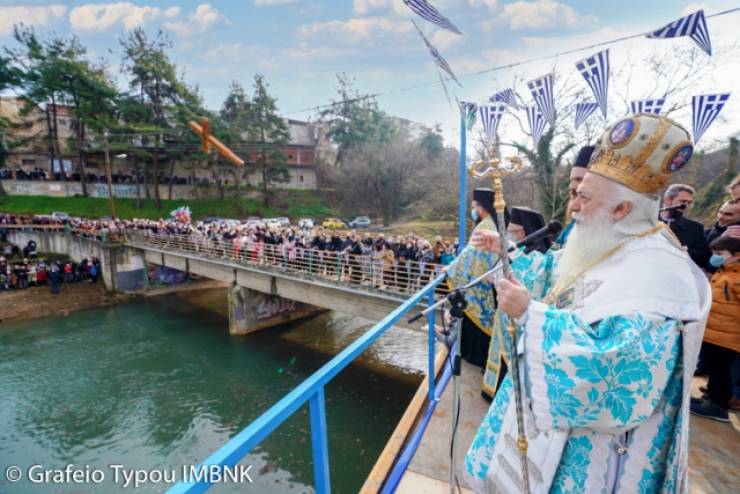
[691,234,740,422]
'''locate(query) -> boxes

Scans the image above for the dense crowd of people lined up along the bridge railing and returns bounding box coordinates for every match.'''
[0,213,458,292]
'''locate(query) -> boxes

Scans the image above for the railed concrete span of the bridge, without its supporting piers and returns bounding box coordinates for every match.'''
[125,233,448,327]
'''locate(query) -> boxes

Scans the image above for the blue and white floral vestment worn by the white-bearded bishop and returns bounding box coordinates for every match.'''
[465,232,711,494]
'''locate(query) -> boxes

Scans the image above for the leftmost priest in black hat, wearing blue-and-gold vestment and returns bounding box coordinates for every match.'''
[446,188,496,367]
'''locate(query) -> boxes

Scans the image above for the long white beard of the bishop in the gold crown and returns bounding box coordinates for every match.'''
[555,208,629,280]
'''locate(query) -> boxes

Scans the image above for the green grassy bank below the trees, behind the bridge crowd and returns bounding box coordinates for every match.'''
[0,190,333,219]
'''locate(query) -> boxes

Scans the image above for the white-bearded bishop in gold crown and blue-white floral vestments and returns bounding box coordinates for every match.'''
[465,113,712,493]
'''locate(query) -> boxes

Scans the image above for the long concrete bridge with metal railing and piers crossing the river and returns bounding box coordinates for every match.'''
[5,225,444,334]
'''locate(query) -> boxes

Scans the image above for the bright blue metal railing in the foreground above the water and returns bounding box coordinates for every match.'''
[168,274,445,494]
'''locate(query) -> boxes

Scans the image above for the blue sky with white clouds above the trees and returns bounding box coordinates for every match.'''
[0,0,740,149]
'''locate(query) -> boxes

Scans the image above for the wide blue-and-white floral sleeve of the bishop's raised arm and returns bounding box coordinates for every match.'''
[524,302,680,434]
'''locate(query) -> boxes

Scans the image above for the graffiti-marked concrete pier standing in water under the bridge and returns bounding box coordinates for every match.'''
[229,283,326,335]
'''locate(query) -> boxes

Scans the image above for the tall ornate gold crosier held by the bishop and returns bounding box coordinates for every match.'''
[469,152,529,494]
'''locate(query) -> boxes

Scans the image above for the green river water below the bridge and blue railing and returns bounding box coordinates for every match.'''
[0,290,427,494]
